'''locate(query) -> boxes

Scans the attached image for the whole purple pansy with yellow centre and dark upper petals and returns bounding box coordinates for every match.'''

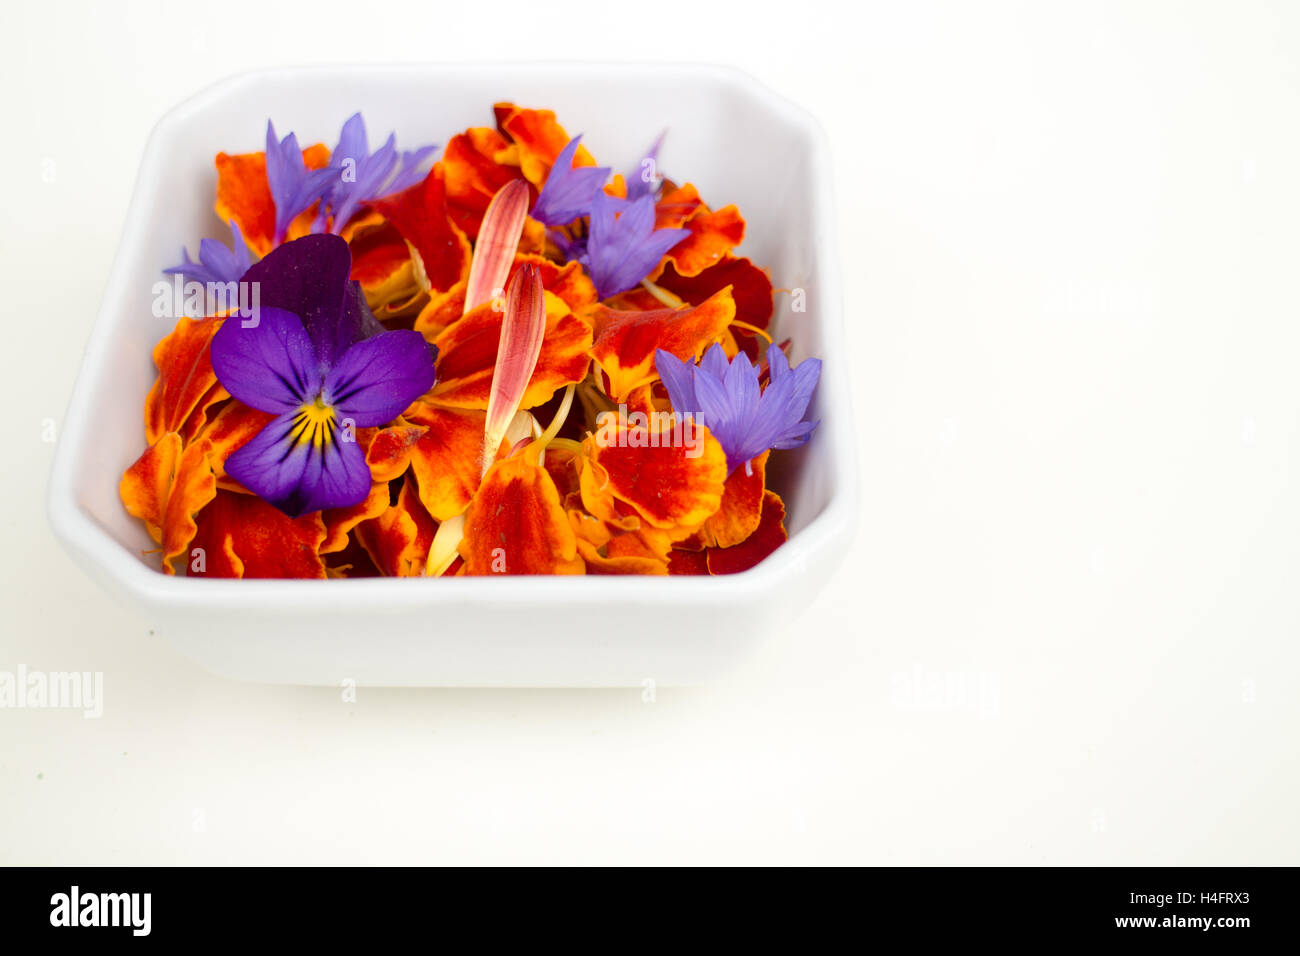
[212,234,434,518]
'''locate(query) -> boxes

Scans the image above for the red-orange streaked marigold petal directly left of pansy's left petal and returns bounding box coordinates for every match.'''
[144,317,230,445]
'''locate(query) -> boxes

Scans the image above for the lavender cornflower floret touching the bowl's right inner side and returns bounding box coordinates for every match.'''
[655,343,822,475]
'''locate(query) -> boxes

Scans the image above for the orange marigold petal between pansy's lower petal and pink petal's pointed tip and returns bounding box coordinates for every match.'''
[406,403,486,522]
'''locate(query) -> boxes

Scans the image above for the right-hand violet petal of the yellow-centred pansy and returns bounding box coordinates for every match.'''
[325,329,433,427]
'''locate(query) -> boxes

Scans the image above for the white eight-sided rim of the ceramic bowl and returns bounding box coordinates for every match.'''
[46,61,859,613]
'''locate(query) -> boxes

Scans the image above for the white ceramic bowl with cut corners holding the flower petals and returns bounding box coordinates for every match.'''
[49,65,858,687]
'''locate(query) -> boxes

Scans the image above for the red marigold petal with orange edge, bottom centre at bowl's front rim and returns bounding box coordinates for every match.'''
[459,455,584,575]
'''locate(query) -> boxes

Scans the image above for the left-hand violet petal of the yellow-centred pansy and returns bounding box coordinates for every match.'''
[211,306,321,414]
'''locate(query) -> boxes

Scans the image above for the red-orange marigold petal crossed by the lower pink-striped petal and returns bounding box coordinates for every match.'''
[429,293,592,410]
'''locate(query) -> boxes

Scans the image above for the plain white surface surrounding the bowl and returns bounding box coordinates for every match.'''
[0,0,1300,864]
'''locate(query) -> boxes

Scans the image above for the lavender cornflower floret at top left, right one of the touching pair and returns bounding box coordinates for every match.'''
[316,113,438,233]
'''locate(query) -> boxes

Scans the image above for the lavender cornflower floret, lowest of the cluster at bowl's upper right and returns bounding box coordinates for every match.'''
[582,191,690,299]
